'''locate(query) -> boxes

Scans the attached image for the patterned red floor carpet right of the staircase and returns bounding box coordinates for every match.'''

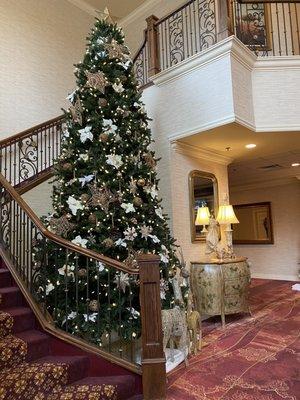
[168,280,300,400]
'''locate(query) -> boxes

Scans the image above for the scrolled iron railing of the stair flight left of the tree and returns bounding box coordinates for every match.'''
[0,116,64,191]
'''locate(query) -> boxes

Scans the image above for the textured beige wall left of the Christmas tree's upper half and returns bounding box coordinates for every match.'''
[0,0,93,138]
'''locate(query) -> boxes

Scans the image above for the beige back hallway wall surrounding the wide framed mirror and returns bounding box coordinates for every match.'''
[230,178,300,280]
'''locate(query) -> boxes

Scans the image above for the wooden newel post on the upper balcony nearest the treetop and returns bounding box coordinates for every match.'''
[146,15,160,76]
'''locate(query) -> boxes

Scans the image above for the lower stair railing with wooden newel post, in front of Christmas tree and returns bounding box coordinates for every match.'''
[0,174,166,399]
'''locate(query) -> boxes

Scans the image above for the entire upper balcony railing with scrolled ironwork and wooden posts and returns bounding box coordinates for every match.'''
[134,0,300,87]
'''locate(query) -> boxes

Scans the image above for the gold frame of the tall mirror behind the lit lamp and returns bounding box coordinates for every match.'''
[189,170,219,243]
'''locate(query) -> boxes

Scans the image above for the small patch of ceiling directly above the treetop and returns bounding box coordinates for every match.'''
[84,0,146,19]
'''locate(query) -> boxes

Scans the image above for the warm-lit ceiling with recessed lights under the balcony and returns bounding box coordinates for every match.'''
[180,123,300,186]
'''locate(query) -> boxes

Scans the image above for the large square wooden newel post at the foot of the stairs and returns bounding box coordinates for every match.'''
[138,254,166,400]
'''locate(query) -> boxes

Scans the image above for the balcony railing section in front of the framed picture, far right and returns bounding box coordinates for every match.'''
[231,0,300,56]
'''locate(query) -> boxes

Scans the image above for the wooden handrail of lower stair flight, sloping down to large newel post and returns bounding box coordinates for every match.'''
[0,174,139,274]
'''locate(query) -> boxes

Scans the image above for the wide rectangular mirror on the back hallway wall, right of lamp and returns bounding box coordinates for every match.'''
[233,202,274,244]
